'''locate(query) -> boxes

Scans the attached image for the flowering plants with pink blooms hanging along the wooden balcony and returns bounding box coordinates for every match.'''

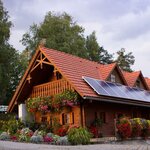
[26,90,78,113]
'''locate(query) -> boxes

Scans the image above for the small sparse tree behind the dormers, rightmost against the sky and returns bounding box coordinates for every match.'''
[116,48,135,72]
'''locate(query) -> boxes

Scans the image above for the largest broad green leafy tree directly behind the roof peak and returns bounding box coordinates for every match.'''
[22,12,87,58]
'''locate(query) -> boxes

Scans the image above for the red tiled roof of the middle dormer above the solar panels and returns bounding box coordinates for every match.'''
[122,71,149,90]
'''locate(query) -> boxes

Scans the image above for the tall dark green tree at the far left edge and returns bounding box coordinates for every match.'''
[0,0,22,104]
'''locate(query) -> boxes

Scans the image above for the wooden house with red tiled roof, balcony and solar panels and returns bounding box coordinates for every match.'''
[8,46,150,136]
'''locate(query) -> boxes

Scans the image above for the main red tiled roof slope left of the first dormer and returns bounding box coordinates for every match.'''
[41,47,101,97]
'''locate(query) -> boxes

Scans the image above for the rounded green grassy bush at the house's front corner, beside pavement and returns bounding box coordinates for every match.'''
[68,127,91,145]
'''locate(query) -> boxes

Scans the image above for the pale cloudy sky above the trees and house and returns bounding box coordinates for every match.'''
[2,0,150,77]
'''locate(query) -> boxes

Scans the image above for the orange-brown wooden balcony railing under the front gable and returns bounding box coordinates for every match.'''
[30,79,73,97]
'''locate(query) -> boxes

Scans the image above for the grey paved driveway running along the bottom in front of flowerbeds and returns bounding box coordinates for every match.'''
[0,141,150,150]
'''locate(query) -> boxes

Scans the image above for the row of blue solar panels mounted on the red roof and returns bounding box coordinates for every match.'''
[82,77,150,102]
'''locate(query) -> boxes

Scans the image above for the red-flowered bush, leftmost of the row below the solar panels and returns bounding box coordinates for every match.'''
[117,117,132,139]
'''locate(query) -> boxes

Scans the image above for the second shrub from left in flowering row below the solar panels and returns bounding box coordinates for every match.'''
[130,118,143,137]
